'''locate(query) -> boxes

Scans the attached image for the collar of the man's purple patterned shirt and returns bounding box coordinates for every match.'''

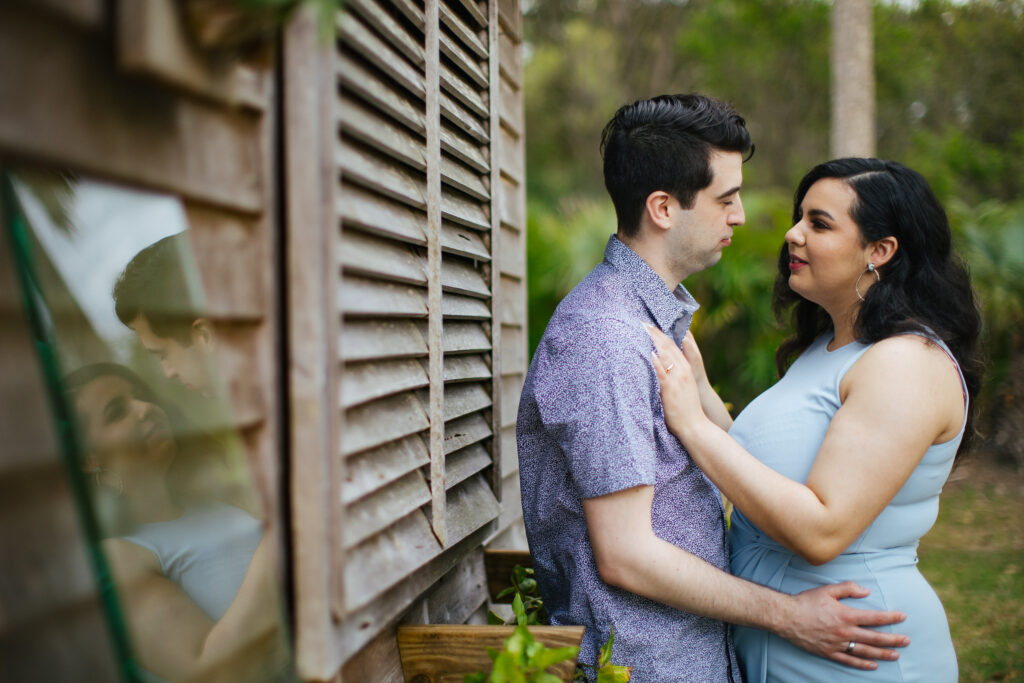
[604,234,700,343]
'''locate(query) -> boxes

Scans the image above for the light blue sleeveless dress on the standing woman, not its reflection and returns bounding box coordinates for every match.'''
[729,332,967,683]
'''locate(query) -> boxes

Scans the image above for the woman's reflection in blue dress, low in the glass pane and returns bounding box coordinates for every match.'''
[66,364,281,681]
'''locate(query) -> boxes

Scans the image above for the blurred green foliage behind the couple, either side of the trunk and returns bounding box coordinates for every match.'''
[524,0,1024,438]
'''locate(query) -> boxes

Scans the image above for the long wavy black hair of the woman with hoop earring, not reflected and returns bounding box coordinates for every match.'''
[772,159,983,458]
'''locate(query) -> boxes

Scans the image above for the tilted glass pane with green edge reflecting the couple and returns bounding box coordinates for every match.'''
[2,170,293,681]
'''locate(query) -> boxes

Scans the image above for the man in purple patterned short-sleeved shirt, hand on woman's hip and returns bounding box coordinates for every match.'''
[516,95,906,683]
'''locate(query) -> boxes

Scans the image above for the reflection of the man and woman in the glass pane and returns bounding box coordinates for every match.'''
[67,234,281,681]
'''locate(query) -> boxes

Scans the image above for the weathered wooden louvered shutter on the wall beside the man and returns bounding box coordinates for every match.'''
[323,0,520,659]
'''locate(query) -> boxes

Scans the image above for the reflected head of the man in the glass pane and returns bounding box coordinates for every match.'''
[114,232,218,396]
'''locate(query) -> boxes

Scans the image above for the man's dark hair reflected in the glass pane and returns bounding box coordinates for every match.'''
[114,232,203,346]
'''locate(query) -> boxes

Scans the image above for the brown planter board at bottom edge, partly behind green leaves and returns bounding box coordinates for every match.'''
[398,625,584,683]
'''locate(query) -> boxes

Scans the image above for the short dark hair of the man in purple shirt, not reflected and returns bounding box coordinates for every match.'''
[601,94,754,237]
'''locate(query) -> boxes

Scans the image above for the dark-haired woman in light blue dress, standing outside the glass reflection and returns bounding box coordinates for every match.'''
[651,159,980,683]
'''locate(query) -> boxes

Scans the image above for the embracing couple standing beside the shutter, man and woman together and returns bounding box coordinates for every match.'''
[517,95,980,683]
